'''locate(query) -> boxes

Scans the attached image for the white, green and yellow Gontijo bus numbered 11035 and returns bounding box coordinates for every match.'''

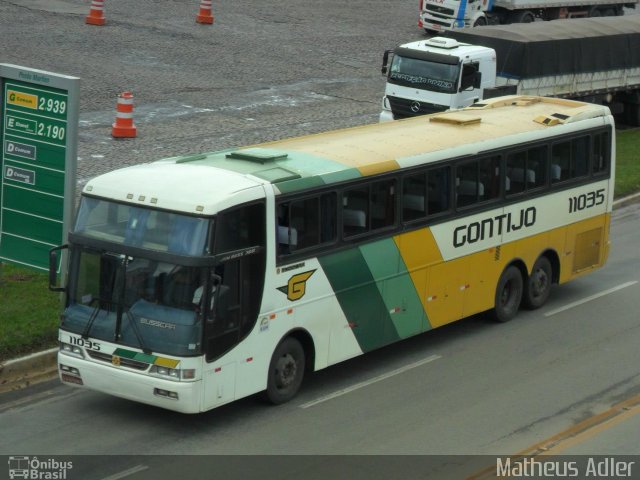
[50,96,615,413]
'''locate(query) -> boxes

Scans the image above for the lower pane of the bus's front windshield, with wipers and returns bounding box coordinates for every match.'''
[61,248,208,355]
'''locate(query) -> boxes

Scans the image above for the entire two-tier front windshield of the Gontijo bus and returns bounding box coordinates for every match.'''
[61,196,214,355]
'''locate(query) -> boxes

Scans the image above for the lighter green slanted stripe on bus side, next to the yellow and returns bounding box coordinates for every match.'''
[360,238,430,338]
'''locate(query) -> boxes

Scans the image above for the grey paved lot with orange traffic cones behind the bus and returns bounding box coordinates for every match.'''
[0,0,425,183]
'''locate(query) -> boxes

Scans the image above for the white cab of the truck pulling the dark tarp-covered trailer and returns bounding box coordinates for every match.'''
[380,37,496,122]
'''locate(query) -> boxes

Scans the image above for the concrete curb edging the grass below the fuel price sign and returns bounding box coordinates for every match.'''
[0,348,58,393]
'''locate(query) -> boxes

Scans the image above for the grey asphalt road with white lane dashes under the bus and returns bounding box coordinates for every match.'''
[0,204,640,480]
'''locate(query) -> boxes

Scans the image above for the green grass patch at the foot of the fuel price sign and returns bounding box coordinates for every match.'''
[0,264,61,361]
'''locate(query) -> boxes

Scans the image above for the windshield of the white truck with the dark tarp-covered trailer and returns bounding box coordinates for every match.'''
[389,54,460,93]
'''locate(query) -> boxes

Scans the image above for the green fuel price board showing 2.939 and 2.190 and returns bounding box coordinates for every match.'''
[0,64,79,270]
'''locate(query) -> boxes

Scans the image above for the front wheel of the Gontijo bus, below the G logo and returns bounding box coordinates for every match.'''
[265,337,305,405]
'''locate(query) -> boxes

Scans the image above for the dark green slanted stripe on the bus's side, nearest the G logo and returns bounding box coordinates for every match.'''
[319,248,400,352]
